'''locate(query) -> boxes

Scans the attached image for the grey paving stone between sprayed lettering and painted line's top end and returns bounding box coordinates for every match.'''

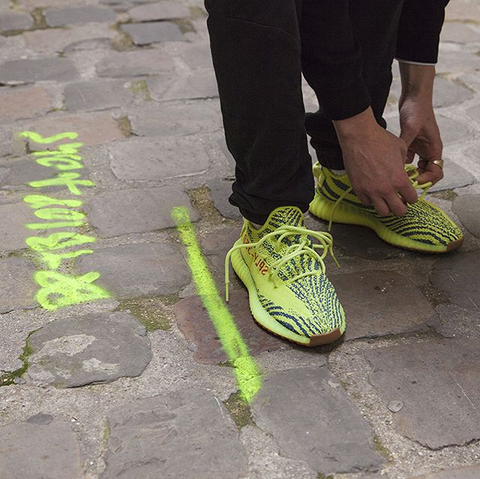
[86,186,199,237]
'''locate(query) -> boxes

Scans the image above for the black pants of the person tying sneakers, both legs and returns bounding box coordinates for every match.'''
[206,0,403,223]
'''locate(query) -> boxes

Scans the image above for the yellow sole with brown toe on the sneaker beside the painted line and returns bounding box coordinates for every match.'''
[232,244,345,348]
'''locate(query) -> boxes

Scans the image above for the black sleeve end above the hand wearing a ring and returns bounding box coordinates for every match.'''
[396,0,449,63]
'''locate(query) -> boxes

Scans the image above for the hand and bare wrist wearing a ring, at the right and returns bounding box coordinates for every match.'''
[399,63,443,188]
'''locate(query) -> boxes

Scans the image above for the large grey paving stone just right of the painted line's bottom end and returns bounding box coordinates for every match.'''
[252,368,382,474]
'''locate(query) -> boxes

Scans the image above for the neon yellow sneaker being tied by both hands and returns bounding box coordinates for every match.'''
[310,163,463,253]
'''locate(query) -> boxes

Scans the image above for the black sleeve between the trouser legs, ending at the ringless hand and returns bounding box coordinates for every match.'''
[301,0,372,120]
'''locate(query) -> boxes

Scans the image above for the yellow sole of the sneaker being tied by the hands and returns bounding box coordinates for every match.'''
[309,193,464,253]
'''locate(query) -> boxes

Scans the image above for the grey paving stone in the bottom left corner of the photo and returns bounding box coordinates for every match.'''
[0,421,83,479]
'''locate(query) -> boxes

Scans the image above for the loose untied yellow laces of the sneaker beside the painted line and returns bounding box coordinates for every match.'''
[225,225,339,301]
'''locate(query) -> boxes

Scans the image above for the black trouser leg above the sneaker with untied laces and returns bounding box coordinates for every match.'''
[206,0,314,223]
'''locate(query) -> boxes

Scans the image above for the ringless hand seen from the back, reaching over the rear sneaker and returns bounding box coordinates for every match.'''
[334,108,418,216]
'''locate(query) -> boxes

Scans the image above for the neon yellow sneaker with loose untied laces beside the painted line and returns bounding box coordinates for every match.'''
[225,206,345,347]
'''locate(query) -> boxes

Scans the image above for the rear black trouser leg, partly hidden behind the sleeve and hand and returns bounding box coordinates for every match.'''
[301,0,403,170]
